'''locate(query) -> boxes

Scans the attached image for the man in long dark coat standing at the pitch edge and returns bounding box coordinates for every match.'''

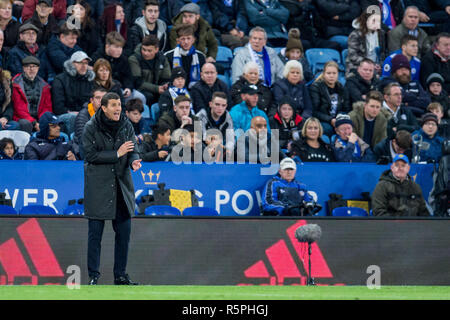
[83,92,142,285]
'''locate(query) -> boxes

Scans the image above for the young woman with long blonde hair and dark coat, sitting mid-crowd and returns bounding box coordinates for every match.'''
[309,61,351,137]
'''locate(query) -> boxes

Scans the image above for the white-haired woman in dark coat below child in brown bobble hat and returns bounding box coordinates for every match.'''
[272,60,312,119]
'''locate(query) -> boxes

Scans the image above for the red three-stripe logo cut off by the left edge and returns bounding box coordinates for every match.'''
[0,219,64,285]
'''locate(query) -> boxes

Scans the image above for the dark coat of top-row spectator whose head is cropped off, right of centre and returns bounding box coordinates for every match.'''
[316,0,361,39]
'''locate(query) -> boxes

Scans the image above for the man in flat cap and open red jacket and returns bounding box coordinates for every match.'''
[12,55,53,134]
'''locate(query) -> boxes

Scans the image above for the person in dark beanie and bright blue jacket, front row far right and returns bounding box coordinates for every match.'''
[411,112,444,163]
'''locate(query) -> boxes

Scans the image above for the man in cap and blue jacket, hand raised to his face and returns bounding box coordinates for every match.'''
[332,114,375,162]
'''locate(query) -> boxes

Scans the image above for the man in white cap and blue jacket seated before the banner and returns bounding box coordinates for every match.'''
[262,158,320,216]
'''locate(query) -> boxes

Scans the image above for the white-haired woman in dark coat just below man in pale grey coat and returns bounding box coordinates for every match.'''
[230,61,276,116]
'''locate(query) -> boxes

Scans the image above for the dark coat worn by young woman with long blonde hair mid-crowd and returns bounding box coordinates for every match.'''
[309,80,351,123]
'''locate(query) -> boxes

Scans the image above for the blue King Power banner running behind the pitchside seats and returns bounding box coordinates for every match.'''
[0,161,433,216]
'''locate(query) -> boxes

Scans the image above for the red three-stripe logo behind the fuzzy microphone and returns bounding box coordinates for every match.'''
[238,220,344,285]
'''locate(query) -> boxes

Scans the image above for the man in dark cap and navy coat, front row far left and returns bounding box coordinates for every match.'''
[24,112,77,161]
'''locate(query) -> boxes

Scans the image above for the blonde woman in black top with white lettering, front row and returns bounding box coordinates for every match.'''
[290,117,335,162]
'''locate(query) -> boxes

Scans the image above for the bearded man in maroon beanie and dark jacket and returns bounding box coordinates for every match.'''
[379,54,431,117]
